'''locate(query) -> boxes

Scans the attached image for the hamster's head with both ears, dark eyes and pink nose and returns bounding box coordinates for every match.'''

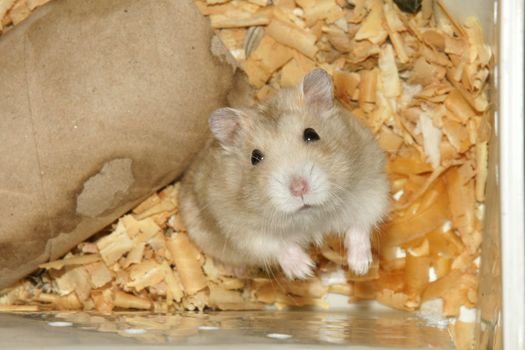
[210,69,368,224]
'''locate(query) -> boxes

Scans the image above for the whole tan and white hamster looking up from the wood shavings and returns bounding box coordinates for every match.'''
[179,69,389,279]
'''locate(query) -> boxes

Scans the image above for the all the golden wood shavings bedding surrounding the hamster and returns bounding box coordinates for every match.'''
[0,0,492,347]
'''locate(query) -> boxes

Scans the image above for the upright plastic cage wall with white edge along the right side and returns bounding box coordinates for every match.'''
[444,0,525,349]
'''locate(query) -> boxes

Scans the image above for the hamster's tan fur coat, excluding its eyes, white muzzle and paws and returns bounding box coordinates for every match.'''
[180,69,388,276]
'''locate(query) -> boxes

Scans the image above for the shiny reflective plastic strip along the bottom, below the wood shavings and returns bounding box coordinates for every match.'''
[0,304,453,349]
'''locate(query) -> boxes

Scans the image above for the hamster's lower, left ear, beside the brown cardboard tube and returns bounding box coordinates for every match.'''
[208,108,242,145]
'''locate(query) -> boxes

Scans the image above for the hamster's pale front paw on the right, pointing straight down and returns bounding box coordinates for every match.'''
[346,229,372,276]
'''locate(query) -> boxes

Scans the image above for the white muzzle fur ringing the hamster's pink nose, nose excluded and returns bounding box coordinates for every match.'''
[268,161,330,213]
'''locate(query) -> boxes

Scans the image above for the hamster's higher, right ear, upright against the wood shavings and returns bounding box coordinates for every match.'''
[300,68,334,111]
